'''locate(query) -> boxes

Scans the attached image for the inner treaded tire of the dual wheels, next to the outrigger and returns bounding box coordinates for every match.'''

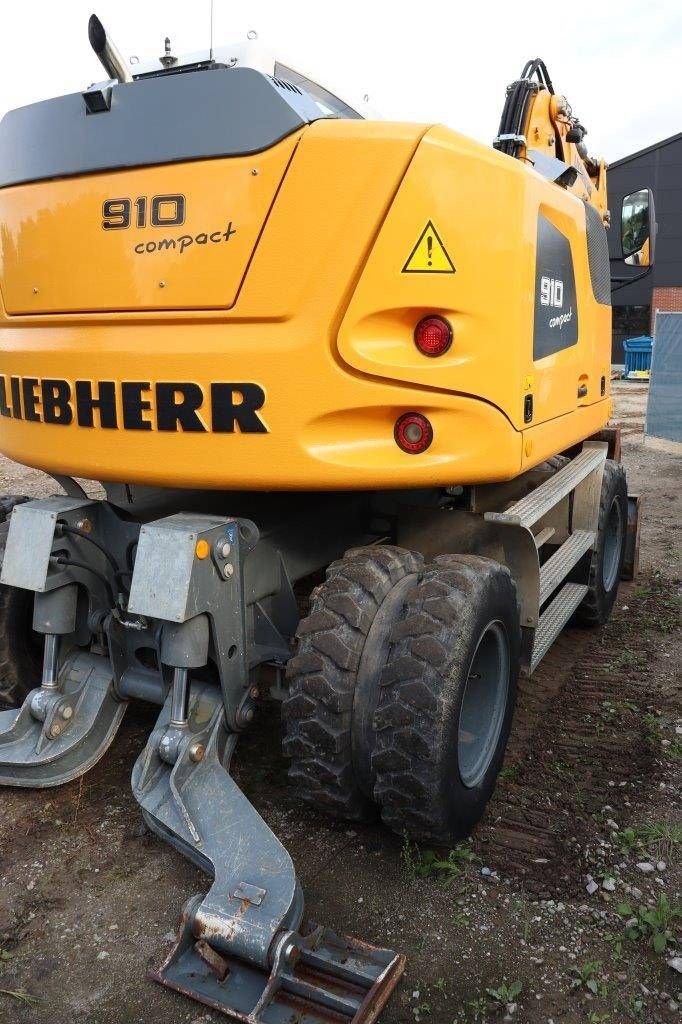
[282,546,423,821]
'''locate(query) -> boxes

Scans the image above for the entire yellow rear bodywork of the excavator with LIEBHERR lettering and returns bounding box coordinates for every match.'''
[0,120,610,489]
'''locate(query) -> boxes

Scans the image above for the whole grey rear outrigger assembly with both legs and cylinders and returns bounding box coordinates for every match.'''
[0,498,404,1024]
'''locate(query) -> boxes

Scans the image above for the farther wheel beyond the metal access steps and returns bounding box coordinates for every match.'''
[574,459,628,626]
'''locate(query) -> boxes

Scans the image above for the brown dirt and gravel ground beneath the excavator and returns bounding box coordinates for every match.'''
[0,383,682,1024]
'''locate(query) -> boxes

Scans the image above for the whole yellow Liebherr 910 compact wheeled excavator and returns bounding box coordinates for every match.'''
[0,15,655,1024]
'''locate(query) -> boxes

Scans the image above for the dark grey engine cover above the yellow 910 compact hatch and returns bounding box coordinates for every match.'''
[0,68,325,187]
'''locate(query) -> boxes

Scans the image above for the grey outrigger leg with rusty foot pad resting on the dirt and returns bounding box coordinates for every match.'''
[132,686,404,1024]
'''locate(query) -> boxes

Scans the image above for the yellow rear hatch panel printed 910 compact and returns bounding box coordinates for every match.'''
[0,134,299,313]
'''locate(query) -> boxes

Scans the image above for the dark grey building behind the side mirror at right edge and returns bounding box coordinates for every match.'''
[608,132,682,362]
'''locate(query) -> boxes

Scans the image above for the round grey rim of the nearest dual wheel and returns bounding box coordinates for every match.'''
[458,621,509,788]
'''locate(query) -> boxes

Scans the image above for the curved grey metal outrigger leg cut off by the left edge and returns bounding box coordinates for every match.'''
[0,653,127,790]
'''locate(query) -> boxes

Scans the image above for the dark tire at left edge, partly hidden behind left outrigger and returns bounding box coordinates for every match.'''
[0,495,43,708]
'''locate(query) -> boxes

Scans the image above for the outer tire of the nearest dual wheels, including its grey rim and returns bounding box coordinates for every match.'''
[372,555,521,843]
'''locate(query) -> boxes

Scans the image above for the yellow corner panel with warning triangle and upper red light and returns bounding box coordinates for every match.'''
[339,128,610,430]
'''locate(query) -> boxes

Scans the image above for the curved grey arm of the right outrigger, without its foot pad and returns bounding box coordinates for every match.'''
[132,686,302,965]
